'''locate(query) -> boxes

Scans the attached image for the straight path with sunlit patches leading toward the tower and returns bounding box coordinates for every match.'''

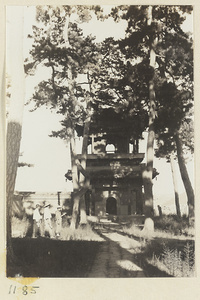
[88,228,145,278]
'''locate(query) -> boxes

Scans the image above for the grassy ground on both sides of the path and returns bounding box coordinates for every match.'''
[7,216,195,277]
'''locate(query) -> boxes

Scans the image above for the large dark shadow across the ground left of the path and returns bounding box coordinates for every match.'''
[7,238,101,277]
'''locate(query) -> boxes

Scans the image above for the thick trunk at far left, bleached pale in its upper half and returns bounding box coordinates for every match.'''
[6,6,24,262]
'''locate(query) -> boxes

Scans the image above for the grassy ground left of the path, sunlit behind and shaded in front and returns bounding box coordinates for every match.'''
[7,217,102,277]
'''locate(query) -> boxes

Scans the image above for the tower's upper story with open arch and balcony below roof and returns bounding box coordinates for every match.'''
[78,110,145,181]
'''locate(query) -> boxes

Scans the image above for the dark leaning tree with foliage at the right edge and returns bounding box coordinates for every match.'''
[153,6,194,216]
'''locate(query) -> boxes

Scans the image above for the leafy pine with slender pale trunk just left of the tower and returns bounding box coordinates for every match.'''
[26,6,101,229]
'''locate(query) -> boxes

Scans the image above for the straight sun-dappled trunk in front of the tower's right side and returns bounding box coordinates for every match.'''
[143,6,157,232]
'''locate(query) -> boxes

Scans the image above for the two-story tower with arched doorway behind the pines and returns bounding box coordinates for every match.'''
[78,109,144,216]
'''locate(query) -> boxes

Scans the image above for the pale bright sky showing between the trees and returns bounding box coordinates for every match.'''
[7,7,193,214]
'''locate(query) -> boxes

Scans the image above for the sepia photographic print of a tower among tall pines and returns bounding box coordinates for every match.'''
[5,3,198,290]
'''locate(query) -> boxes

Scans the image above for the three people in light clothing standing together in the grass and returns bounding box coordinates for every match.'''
[33,204,63,238]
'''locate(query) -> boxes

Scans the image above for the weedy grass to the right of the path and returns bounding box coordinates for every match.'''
[120,215,195,277]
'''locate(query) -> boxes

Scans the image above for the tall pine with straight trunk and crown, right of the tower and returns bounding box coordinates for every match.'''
[112,6,192,229]
